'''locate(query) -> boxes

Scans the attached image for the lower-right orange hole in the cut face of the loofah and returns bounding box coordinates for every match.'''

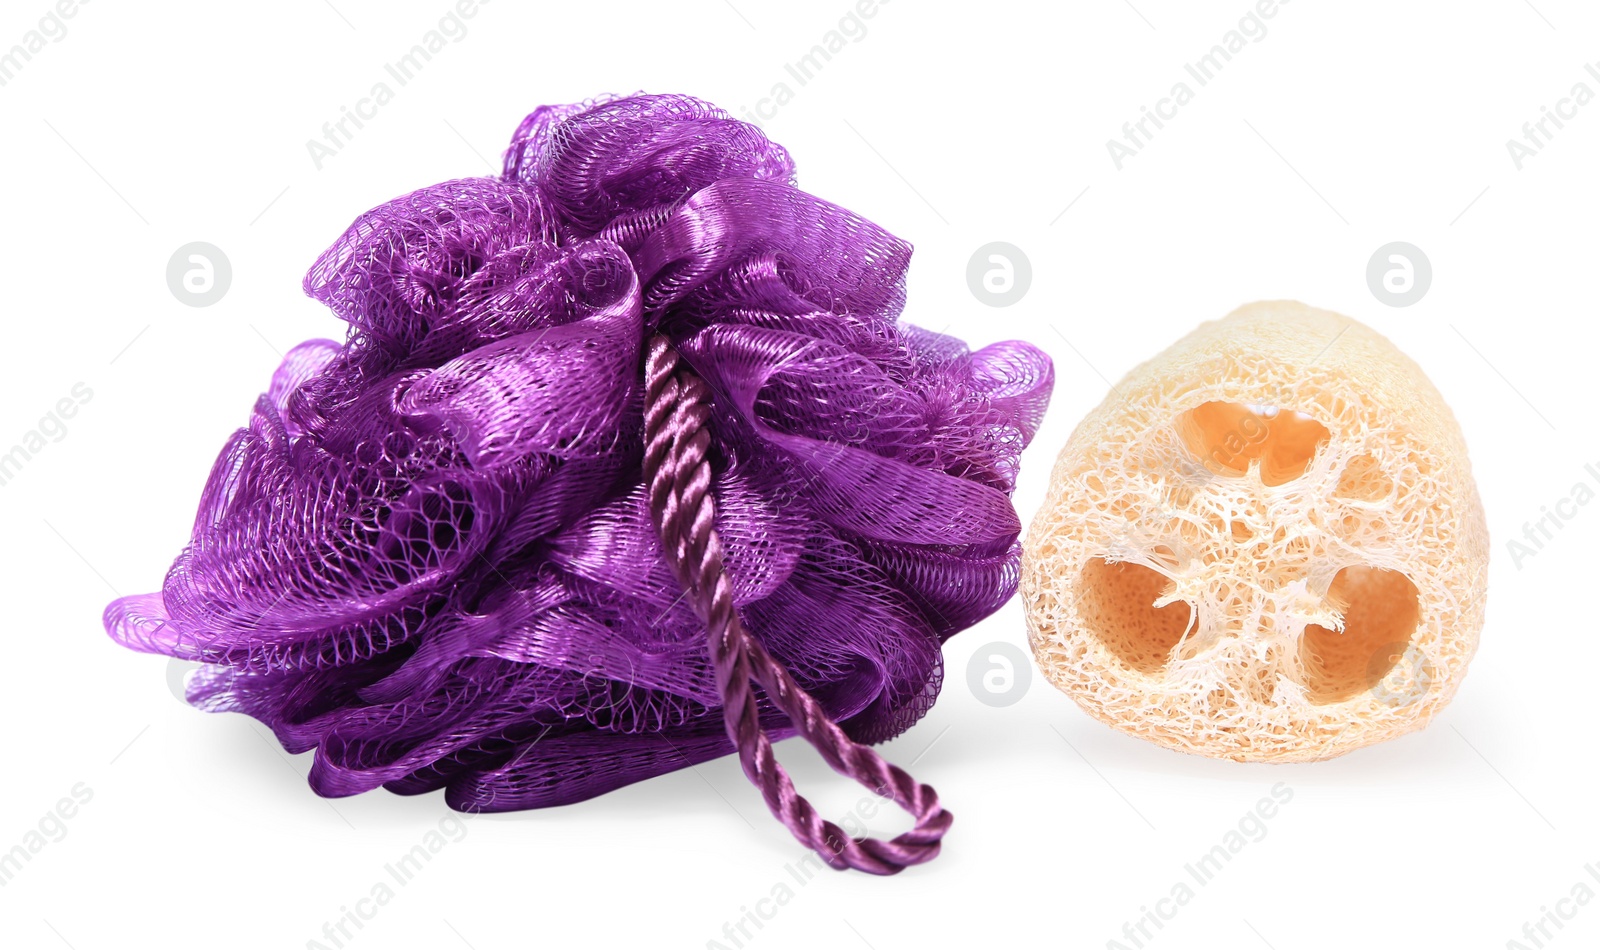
[1301,566,1418,702]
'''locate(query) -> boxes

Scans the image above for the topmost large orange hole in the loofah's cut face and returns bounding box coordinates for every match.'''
[1178,403,1328,486]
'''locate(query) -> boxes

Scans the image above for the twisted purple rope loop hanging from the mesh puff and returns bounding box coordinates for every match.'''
[645,334,952,875]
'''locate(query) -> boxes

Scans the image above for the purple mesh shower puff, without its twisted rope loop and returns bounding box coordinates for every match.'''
[106,96,1051,811]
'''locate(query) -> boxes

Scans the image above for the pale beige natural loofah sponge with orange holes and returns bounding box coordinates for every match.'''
[1022,302,1488,761]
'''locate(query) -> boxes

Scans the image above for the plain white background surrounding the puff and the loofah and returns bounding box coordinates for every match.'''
[0,0,1600,950]
